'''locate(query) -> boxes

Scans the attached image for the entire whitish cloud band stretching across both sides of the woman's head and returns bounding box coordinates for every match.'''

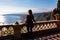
[0,6,53,14]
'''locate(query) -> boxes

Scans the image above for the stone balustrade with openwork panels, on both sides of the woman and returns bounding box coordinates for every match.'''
[0,20,60,37]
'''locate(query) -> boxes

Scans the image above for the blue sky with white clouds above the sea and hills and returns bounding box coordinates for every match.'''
[0,0,57,14]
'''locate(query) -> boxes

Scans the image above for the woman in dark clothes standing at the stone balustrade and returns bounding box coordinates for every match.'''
[26,10,35,33]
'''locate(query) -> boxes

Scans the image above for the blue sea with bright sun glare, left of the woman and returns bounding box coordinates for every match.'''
[0,14,26,25]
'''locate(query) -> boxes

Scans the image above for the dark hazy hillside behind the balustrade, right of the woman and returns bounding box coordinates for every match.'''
[34,12,51,21]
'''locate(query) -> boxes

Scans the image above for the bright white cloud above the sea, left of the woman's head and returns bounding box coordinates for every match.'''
[0,6,27,14]
